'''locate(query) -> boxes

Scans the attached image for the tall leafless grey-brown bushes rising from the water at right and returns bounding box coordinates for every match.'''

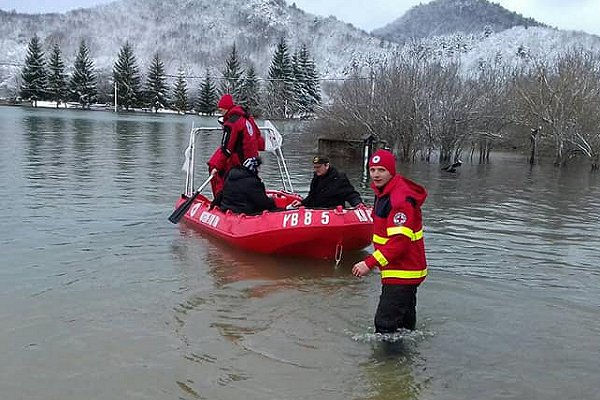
[313,49,600,169]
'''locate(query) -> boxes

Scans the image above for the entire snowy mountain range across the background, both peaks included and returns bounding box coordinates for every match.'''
[0,0,600,97]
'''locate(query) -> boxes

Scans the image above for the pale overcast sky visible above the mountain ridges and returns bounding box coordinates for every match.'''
[0,0,600,35]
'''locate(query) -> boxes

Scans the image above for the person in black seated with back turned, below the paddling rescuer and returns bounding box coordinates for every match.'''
[212,157,279,215]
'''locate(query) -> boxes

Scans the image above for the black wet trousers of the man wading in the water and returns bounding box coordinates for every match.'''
[375,285,417,333]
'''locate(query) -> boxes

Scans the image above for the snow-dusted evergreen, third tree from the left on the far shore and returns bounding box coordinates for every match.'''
[69,40,96,108]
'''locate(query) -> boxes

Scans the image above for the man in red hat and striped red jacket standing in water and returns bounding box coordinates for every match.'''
[352,150,427,333]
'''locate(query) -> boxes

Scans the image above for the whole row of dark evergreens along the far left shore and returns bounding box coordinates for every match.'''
[19,35,321,118]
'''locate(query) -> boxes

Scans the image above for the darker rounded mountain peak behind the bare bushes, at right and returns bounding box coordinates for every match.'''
[371,0,545,43]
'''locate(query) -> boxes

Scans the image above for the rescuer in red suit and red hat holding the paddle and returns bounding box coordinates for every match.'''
[207,94,265,198]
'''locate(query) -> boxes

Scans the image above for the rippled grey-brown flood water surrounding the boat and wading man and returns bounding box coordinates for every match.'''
[0,107,600,400]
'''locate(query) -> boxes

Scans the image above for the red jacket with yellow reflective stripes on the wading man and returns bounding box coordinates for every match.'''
[365,175,427,285]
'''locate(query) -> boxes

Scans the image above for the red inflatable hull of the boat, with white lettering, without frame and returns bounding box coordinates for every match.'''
[176,192,373,259]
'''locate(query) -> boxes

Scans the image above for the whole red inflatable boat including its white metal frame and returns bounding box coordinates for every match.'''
[169,121,373,262]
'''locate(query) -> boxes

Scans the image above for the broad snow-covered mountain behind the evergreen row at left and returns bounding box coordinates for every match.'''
[0,0,397,96]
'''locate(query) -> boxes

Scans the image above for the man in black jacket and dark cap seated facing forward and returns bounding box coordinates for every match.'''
[290,156,363,208]
